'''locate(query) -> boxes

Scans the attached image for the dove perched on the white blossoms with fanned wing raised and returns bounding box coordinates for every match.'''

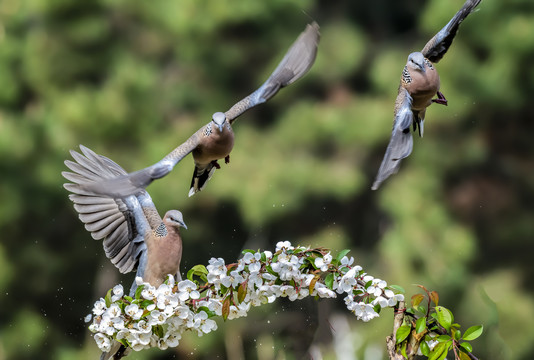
[62,145,187,296]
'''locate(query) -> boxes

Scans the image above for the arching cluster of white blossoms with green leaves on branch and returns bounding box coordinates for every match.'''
[87,241,403,351]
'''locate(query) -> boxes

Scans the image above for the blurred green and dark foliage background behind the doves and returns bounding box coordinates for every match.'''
[0,0,534,360]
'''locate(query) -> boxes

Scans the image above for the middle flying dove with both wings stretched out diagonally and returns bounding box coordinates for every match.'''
[84,23,319,198]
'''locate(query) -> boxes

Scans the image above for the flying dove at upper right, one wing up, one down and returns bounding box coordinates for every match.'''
[372,0,481,190]
